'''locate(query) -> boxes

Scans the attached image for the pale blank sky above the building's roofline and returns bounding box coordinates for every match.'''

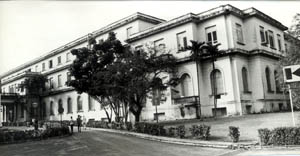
[0,1,300,75]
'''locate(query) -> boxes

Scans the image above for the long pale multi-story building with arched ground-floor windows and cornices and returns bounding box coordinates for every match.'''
[1,5,298,121]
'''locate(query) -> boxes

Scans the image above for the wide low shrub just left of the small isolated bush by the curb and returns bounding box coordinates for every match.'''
[190,124,210,140]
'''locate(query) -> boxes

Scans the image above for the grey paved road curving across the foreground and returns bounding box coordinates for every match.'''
[0,131,233,156]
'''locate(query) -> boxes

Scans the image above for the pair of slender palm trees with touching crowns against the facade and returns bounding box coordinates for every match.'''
[187,40,223,119]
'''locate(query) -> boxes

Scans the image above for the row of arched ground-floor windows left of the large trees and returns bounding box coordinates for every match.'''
[49,96,95,115]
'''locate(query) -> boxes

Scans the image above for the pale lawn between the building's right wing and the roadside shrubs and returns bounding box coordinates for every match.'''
[163,112,300,142]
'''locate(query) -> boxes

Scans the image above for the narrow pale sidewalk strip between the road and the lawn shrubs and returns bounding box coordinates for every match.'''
[89,128,258,149]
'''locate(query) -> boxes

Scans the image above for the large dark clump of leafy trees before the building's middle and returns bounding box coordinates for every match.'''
[67,32,176,122]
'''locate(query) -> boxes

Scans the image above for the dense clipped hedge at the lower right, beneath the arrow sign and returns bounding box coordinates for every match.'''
[258,127,300,145]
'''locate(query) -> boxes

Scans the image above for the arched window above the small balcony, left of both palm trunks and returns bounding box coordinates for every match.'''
[181,74,193,97]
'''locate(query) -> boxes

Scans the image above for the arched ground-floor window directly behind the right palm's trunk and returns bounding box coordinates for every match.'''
[210,69,224,95]
